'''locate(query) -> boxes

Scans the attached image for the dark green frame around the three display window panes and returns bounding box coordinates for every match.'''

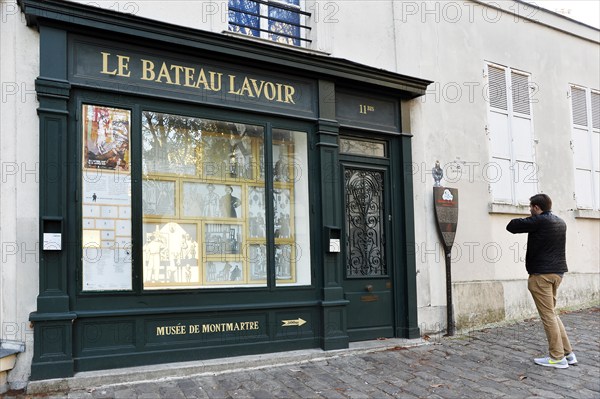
[68,89,318,308]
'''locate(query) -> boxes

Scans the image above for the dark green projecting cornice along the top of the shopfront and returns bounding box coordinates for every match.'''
[18,0,431,99]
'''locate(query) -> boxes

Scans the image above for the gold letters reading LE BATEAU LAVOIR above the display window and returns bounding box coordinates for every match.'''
[100,52,296,104]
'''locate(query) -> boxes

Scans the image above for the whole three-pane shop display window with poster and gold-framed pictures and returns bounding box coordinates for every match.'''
[82,104,311,291]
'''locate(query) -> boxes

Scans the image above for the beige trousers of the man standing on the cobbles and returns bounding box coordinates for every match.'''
[527,274,573,360]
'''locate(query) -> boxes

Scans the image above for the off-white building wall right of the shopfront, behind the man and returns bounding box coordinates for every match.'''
[308,1,600,331]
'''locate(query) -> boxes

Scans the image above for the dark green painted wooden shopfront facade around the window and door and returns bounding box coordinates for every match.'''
[19,0,429,379]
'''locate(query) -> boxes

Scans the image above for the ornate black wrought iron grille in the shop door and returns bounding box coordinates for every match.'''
[344,168,387,278]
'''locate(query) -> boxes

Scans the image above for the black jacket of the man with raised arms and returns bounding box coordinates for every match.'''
[506,211,568,274]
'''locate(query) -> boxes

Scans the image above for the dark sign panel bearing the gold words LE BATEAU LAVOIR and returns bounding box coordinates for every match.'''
[70,39,314,115]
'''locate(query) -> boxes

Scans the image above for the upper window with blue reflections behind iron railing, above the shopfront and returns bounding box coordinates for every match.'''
[229,0,310,46]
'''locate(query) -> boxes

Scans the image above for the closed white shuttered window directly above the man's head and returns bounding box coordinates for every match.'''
[483,64,537,205]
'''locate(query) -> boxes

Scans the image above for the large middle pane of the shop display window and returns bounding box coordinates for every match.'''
[142,111,267,289]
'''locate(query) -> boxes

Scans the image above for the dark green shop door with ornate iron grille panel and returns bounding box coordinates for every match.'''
[340,161,394,341]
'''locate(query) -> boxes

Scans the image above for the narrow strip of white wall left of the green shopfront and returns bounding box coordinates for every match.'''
[0,1,41,392]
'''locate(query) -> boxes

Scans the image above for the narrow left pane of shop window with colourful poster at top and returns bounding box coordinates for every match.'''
[81,105,132,291]
